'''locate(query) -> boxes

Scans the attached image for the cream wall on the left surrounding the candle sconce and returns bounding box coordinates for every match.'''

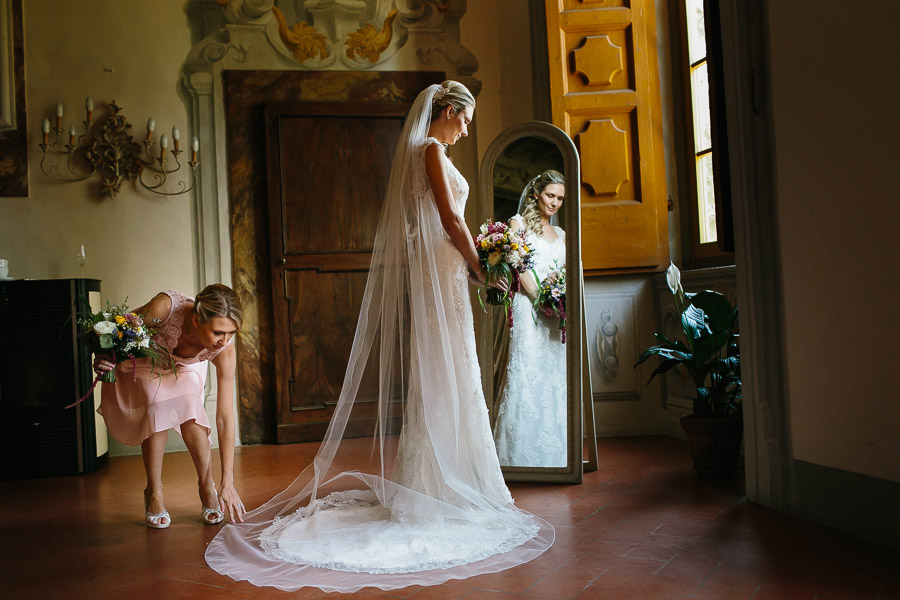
[0,0,194,306]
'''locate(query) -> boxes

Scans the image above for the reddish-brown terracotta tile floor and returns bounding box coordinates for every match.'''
[0,437,900,600]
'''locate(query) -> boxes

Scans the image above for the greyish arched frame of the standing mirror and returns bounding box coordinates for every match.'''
[478,121,597,483]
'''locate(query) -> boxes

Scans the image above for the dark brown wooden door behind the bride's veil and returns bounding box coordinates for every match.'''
[265,102,409,443]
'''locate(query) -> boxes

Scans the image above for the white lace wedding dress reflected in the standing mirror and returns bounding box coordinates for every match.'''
[494,215,568,467]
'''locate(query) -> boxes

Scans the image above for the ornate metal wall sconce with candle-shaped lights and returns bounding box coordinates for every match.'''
[38,97,200,198]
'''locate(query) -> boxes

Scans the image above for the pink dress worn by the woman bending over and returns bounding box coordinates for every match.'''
[97,290,230,446]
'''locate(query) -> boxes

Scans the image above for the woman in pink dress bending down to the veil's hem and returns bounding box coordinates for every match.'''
[94,284,246,529]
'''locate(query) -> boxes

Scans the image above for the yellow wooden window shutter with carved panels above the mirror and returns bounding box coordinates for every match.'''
[545,0,669,274]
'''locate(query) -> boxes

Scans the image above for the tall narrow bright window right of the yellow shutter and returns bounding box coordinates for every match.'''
[673,0,734,266]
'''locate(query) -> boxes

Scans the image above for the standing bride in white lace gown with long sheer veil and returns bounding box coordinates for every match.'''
[206,81,554,592]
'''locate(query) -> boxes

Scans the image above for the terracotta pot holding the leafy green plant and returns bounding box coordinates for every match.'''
[681,415,744,476]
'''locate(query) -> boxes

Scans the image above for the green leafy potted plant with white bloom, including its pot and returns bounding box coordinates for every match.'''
[634,264,743,475]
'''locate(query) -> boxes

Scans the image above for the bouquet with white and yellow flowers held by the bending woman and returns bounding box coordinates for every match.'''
[78,299,160,383]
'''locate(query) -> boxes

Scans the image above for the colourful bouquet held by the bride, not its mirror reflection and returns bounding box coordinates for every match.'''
[475,219,534,327]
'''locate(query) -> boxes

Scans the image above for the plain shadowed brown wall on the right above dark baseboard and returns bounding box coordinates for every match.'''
[768,0,900,482]
